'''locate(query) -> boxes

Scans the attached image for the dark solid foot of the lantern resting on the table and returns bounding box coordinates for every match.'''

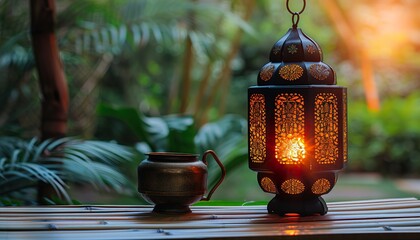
[267,195,328,216]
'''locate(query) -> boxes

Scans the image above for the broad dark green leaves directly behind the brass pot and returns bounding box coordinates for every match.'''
[98,105,248,189]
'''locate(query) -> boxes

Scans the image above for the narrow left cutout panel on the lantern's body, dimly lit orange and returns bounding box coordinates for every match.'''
[249,94,267,163]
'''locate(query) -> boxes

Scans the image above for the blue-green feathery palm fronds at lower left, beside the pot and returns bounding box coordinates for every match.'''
[0,137,134,204]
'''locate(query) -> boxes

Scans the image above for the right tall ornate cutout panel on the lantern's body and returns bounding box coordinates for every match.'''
[315,93,338,164]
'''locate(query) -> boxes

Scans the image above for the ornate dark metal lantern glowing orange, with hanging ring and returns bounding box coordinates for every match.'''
[248,1,347,215]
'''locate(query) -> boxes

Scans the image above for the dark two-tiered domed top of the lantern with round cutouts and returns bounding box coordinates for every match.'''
[258,27,336,85]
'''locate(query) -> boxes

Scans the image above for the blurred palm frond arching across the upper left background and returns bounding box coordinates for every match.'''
[59,0,253,57]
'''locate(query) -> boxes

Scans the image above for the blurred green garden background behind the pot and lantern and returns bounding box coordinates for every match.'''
[0,0,420,205]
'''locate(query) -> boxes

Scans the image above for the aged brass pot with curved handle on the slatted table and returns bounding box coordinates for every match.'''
[137,150,226,213]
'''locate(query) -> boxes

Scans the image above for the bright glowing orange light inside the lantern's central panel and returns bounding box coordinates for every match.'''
[276,134,306,164]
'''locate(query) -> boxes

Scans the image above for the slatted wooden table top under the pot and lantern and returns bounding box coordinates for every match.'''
[0,198,420,240]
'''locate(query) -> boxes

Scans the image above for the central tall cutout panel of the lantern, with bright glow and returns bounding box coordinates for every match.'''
[275,93,305,164]
